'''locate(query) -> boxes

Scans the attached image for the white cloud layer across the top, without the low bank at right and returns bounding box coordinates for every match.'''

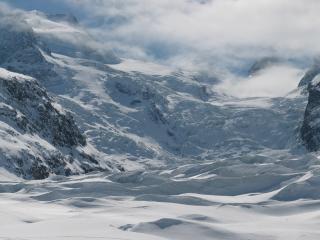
[61,0,320,68]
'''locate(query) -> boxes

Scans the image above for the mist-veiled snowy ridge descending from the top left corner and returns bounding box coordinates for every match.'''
[0,0,119,64]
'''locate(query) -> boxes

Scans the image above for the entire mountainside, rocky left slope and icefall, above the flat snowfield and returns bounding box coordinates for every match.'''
[0,8,312,179]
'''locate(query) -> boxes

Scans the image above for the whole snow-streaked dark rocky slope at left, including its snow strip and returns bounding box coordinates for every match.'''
[0,68,99,179]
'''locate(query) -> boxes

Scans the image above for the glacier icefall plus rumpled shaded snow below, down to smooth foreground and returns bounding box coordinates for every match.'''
[28,47,318,206]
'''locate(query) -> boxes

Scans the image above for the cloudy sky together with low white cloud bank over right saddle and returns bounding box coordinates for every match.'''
[1,0,320,96]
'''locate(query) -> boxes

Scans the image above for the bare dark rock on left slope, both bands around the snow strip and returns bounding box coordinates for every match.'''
[0,73,91,179]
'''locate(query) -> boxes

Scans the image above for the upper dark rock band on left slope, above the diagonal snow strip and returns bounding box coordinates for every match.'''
[0,77,86,147]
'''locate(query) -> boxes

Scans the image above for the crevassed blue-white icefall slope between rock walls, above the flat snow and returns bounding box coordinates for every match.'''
[33,51,306,166]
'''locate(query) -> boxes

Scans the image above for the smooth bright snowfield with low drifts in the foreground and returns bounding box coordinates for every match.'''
[0,171,320,240]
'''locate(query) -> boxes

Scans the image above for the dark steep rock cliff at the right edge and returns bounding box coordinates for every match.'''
[301,81,320,151]
